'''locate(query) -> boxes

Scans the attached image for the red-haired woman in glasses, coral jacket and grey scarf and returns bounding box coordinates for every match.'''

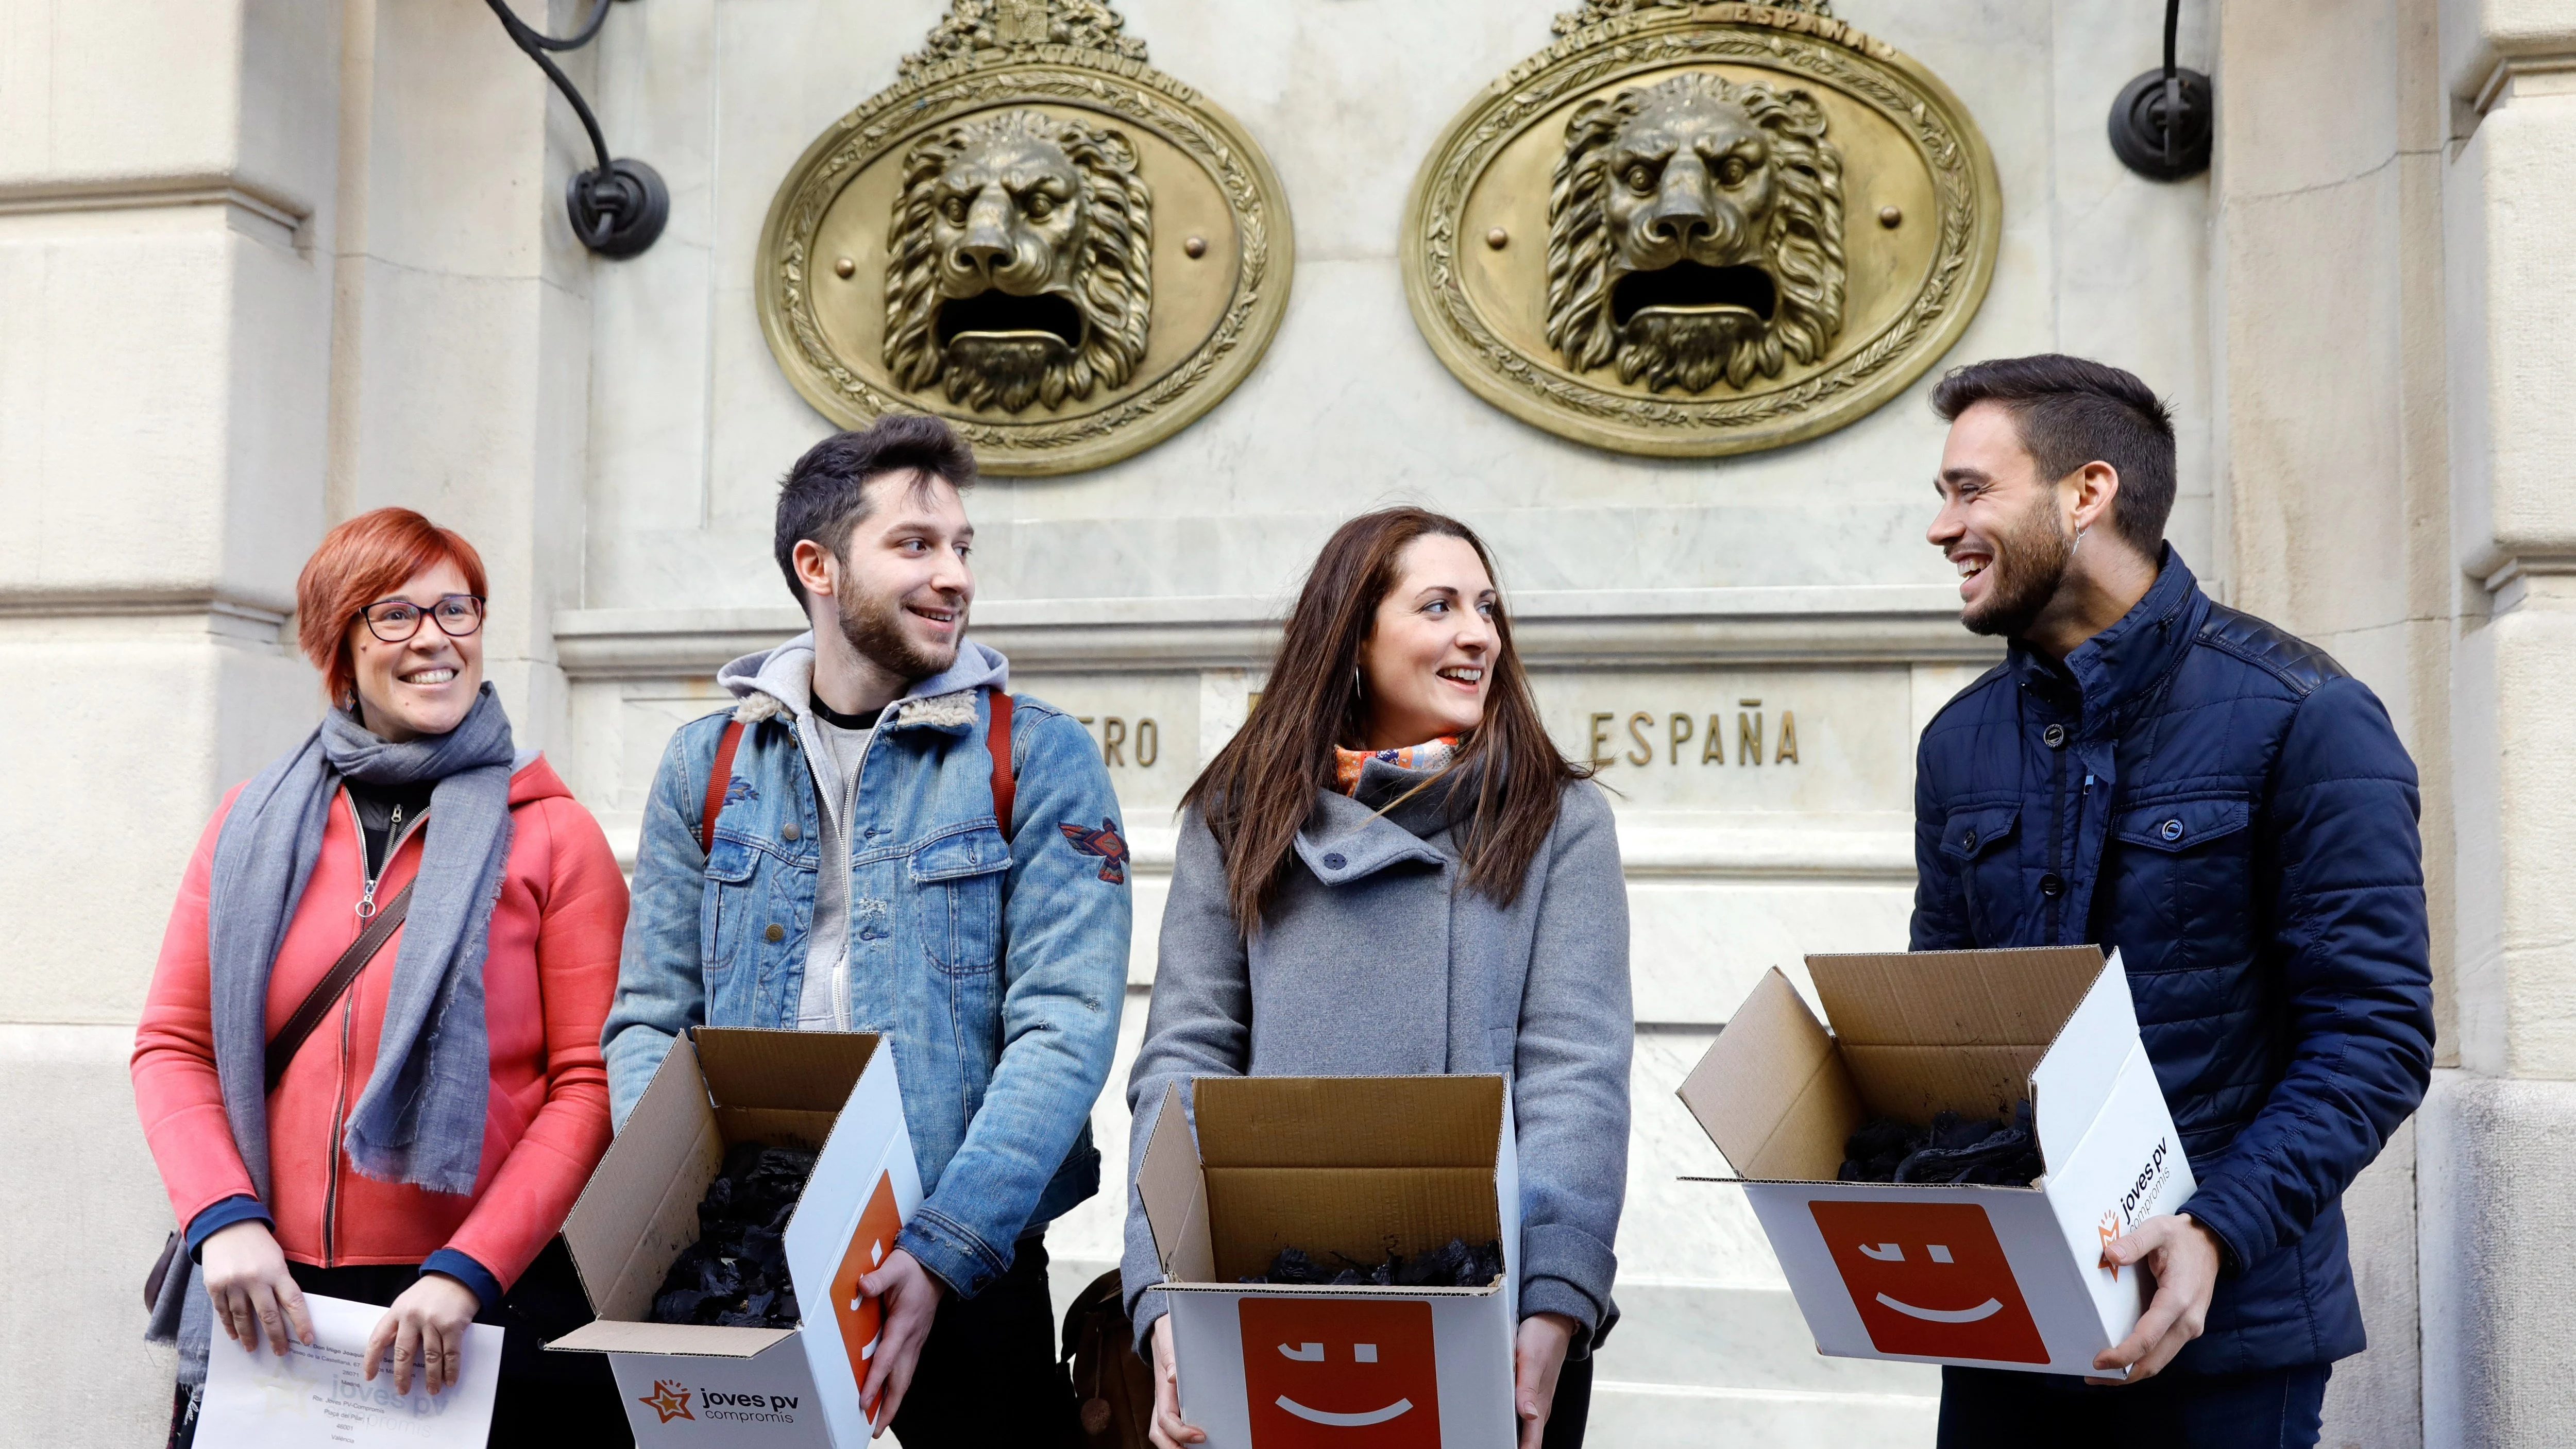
[134,507,626,1446]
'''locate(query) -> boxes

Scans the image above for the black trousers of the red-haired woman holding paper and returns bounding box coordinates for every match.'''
[170,1240,634,1449]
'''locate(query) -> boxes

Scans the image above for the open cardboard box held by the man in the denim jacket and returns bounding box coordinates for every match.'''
[549,1027,922,1449]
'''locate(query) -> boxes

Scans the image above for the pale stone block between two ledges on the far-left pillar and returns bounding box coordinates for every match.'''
[0,215,327,610]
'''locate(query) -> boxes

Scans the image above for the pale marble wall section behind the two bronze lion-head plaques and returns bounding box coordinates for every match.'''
[556,0,2228,1444]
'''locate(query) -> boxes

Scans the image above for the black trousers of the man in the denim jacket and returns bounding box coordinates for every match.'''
[894,1233,1082,1449]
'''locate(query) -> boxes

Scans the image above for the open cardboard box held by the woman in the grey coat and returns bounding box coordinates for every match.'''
[1136,1076,1520,1449]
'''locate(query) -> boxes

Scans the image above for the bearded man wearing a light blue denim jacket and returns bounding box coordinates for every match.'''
[603,417,1128,1444]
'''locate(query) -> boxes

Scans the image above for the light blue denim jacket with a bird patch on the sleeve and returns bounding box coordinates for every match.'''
[600,636,1128,1297]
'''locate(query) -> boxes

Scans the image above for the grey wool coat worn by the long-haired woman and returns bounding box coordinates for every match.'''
[1121,759,1636,1356]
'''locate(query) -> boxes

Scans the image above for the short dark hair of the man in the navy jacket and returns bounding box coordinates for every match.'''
[1932,353,2174,558]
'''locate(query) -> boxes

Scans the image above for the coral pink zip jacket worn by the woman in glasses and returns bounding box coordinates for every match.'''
[134,759,626,1287]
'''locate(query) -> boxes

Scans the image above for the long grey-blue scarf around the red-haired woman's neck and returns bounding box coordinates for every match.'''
[152,685,513,1382]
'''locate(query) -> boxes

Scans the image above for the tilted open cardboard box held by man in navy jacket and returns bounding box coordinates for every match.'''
[1682,947,2195,1374]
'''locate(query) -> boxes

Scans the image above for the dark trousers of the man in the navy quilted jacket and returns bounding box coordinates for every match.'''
[1940,1364,2331,1449]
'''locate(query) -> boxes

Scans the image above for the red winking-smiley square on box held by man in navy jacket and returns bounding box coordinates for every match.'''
[1808,1202,2048,1364]
